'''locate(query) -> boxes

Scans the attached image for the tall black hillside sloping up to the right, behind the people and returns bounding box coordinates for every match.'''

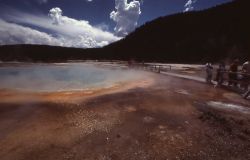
[102,0,250,62]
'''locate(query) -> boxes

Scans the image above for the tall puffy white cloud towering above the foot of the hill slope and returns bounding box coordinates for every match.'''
[110,0,141,37]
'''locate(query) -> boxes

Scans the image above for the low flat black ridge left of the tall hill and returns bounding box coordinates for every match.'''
[0,45,97,62]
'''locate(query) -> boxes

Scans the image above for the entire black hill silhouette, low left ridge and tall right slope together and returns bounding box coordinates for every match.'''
[0,0,250,63]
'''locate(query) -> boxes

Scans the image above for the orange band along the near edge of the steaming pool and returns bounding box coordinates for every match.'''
[0,73,154,103]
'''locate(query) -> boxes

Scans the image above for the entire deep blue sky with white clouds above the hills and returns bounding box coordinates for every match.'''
[0,0,231,48]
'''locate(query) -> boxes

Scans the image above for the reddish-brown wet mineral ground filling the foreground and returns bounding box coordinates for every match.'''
[0,74,250,160]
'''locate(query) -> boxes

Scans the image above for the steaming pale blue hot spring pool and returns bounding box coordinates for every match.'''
[0,63,144,92]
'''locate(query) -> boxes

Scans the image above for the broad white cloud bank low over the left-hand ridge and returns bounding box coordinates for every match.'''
[0,7,120,48]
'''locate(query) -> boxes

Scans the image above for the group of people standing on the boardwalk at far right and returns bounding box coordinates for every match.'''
[206,59,250,98]
